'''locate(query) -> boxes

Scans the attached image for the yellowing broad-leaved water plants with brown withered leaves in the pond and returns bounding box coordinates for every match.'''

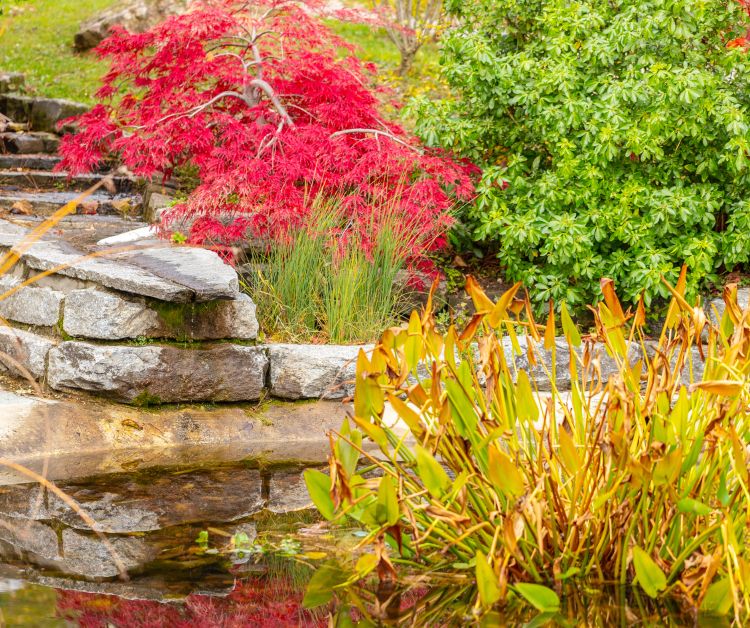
[307,269,750,622]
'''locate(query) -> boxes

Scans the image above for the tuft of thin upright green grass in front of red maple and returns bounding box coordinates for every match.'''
[248,200,413,343]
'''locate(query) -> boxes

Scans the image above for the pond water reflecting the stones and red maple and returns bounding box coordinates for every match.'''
[0,462,729,628]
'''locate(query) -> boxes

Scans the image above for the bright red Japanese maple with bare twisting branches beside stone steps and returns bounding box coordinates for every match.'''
[61,0,475,257]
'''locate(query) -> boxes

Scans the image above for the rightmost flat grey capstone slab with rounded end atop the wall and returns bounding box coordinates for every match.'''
[116,246,239,301]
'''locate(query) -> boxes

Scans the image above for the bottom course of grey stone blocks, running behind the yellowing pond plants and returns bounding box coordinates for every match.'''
[0,327,704,405]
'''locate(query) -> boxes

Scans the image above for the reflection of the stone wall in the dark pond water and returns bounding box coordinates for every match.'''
[0,463,314,580]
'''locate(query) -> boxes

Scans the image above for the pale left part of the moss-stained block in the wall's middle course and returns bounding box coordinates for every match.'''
[63,289,163,340]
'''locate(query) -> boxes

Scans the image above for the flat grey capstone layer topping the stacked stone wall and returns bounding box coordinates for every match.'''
[0,220,239,303]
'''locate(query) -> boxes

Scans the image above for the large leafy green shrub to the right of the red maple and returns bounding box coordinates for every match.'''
[412,0,750,306]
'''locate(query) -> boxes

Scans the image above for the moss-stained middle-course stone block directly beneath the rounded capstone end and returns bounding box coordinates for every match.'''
[62,289,258,340]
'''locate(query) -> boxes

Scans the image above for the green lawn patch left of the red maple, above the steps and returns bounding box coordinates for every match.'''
[0,0,115,103]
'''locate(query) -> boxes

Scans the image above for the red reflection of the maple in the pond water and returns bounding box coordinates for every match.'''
[57,578,328,628]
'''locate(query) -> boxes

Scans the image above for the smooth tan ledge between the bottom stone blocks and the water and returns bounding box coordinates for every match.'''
[0,391,348,486]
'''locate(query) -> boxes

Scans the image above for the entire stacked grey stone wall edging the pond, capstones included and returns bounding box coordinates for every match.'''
[0,220,716,405]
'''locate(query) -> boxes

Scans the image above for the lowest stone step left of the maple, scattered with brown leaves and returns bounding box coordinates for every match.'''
[0,190,141,216]
